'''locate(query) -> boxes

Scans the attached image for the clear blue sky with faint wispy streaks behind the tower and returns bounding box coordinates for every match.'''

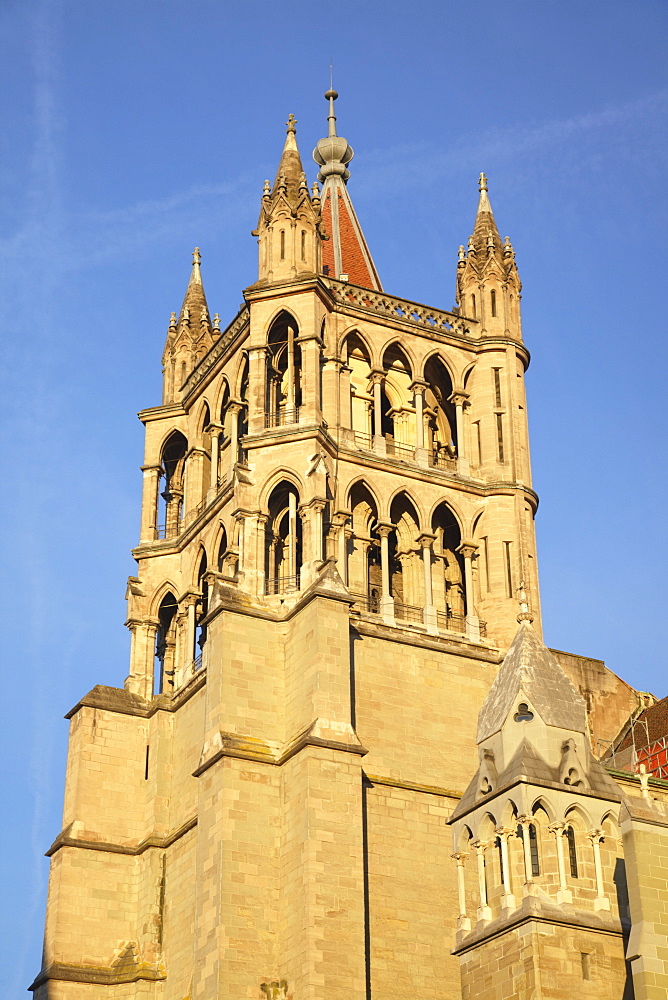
[0,0,668,998]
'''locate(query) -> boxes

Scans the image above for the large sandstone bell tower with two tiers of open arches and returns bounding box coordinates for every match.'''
[32,91,664,1000]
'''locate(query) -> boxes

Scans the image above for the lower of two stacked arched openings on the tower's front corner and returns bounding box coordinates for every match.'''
[265,482,302,594]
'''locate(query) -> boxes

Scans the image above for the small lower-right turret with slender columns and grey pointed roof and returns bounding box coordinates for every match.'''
[448,594,625,1000]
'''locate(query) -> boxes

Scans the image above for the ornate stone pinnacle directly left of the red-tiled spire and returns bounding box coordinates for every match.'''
[253,115,322,284]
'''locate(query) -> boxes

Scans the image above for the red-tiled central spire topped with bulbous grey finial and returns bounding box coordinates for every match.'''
[313,90,382,291]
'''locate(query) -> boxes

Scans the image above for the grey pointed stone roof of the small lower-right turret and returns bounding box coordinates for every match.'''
[478,621,587,743]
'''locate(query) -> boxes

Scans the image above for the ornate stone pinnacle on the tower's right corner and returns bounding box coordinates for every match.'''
[456,174,522,340]
